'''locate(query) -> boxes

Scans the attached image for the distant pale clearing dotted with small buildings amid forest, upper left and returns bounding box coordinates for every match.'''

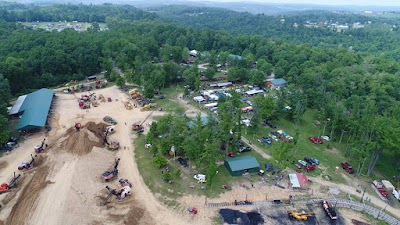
[22,21,107,31]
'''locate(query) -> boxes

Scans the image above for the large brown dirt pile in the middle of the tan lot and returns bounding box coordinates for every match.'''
[60,122,106,155]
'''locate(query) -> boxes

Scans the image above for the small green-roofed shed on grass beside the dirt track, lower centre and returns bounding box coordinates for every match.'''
[224,155,260,176]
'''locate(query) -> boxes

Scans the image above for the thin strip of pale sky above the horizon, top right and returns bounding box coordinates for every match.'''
[195,0,400,6]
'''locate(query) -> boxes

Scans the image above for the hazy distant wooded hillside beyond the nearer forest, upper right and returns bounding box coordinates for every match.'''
[151,6,400,60]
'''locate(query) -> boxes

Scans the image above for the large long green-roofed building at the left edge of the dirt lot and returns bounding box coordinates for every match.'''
[17,88,54,130]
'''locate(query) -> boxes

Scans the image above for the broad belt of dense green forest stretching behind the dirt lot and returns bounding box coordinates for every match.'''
[0,2,400,174]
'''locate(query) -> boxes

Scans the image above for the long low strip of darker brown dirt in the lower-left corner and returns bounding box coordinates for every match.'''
[5,159,51,225]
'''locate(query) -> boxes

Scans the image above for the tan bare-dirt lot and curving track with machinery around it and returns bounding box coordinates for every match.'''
[0,87,396,225]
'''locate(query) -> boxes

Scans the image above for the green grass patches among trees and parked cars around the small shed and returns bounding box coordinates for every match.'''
[135,85,398,210]
